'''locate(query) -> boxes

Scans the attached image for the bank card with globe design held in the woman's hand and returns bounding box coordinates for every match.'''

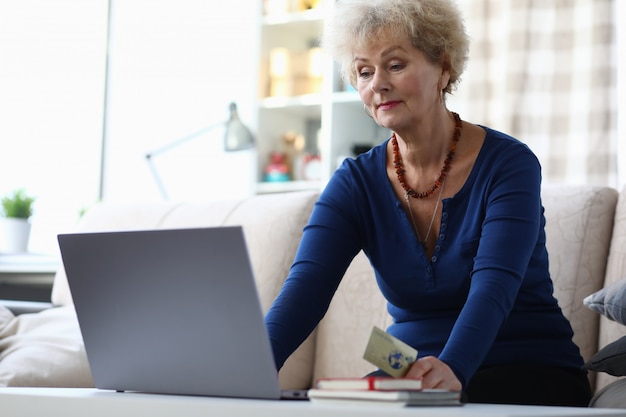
[363,326,417,377]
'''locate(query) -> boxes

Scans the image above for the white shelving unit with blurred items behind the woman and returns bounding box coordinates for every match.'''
[257,0,388,193]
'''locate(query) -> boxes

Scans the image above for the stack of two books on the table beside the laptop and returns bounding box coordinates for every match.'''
[308,377,463,407]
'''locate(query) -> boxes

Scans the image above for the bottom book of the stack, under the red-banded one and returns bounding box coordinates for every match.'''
[308,388,463,407]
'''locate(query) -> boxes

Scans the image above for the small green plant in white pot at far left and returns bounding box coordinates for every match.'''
[0,189,35,253]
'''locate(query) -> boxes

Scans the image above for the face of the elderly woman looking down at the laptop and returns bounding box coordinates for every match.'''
[354,36,450,132]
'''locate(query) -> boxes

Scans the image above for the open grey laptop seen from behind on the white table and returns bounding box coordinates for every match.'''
[58,226,306,399]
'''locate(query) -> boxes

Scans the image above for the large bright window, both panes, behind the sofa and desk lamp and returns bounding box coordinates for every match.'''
[0,0,262,253]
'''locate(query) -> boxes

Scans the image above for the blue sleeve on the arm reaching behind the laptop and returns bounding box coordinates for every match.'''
[265,164,360,369]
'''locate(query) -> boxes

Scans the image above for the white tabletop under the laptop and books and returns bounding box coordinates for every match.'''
[0,388,626,417]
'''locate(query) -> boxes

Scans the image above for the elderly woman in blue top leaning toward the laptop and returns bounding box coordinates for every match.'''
[266,0,591,406]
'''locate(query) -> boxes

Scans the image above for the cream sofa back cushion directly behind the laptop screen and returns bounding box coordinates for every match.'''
[52,191,319,389]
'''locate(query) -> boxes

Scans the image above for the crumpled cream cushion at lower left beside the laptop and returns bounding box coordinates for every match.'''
[0,306,93,387]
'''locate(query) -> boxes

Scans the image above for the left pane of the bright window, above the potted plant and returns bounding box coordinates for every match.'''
[0,0,107,252]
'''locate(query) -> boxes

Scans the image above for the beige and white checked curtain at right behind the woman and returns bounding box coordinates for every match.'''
[450,0,624,186]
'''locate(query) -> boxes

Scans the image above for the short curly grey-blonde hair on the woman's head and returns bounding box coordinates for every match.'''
[322,0,469,93]
